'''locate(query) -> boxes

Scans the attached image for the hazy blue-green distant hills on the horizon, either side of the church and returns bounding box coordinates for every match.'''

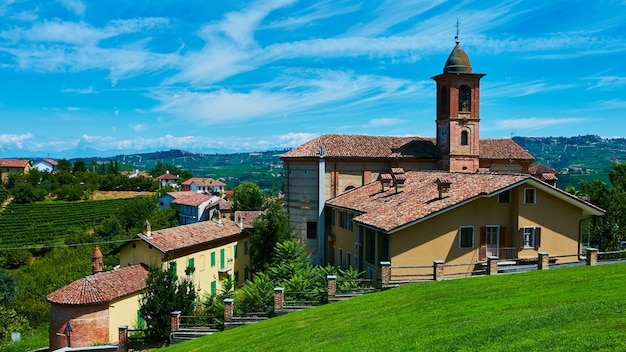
[72,135,626,192]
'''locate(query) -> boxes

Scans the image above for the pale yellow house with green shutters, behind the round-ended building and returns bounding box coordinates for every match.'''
[119,218,250,295]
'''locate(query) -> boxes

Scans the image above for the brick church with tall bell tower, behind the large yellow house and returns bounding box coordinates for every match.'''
[281,37,556,264]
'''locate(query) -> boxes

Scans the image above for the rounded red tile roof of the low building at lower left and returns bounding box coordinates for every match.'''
[46,264,148,305]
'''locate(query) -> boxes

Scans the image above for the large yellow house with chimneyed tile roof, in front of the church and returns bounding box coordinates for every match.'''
[326,168,604,278]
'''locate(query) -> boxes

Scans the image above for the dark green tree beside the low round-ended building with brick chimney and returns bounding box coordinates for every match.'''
[139,265,197,341]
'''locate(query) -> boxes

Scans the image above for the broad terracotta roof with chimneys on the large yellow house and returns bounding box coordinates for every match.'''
[327,171,531,231]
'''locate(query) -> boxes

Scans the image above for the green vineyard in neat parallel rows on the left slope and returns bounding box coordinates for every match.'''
[0,198,132,248]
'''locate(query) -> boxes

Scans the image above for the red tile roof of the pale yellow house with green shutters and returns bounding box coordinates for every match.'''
[137,219,241,253]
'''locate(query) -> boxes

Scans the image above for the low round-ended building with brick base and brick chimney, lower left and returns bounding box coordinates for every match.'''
[46,246,148,350]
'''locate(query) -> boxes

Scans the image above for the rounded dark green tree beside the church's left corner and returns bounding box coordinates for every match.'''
[250,199,293,270]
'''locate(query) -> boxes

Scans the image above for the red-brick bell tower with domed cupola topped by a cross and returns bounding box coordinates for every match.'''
[432,26,484,172]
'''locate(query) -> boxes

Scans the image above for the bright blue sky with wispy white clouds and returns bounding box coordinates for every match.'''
[0,0,626,158]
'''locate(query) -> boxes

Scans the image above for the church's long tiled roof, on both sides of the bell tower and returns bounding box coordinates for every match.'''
[281,134,535,160]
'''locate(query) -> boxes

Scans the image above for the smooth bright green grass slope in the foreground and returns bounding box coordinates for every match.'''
[160,264,626,352]
